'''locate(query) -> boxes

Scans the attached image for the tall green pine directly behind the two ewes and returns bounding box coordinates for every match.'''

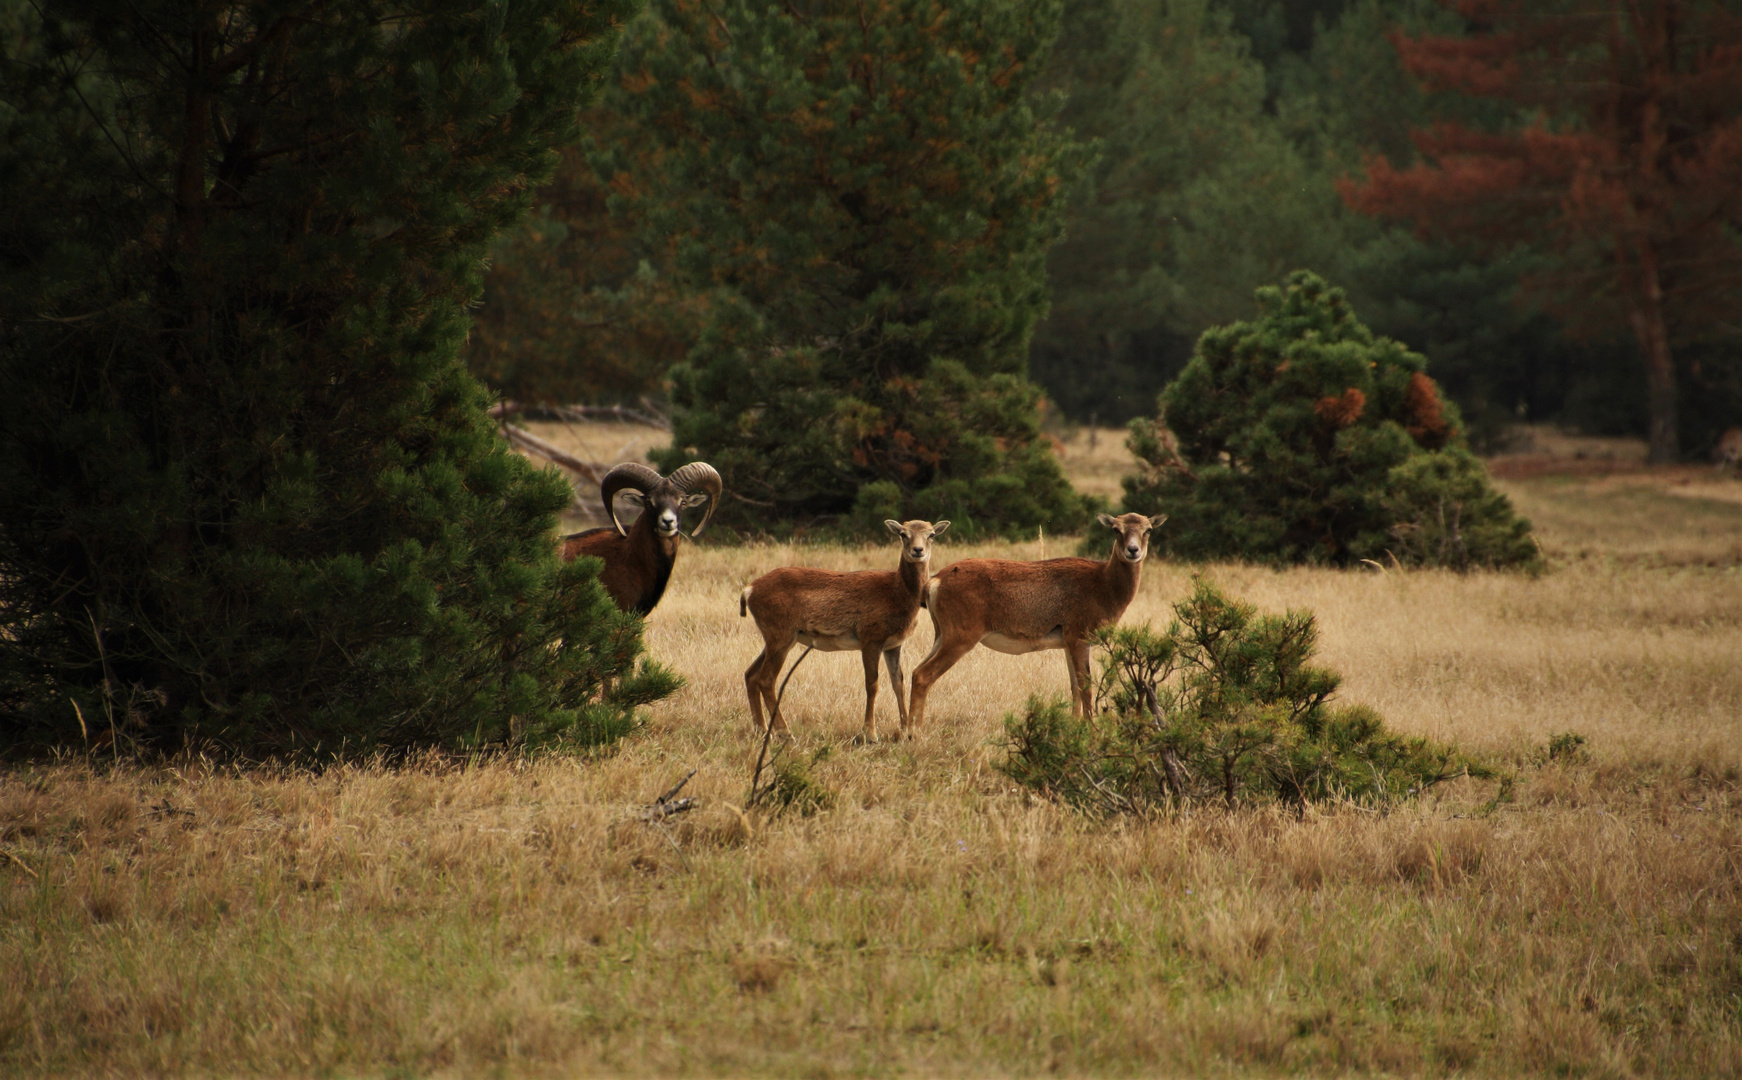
[599,0,1085,533]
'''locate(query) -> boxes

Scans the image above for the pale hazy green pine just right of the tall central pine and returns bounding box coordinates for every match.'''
[1033,0,1343,420]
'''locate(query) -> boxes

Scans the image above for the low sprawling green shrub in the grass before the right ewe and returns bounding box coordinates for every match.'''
[1000,580,1488,813]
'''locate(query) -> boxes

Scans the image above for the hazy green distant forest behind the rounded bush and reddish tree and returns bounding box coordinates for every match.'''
[1033,0,1742,453]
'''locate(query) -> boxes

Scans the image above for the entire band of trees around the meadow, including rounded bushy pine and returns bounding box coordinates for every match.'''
[10,0,1742,753]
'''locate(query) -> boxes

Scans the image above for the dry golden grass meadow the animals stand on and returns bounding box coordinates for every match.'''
[0,432,1742,1077]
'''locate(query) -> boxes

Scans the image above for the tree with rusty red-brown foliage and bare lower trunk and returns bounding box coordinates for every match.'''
[1341,0,1742,460]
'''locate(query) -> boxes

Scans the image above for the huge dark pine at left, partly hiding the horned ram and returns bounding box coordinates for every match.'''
[0,0,671,753]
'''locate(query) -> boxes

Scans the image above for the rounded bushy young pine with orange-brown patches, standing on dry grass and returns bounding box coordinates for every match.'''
[1124,270,1538,570]
